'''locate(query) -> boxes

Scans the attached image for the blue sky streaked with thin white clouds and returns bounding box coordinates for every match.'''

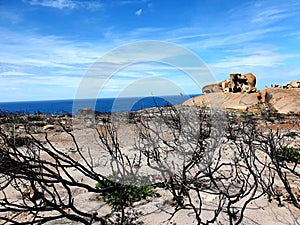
[0,0,300,102]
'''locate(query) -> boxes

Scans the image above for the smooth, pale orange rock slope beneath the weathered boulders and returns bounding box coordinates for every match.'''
[183,88,300,114]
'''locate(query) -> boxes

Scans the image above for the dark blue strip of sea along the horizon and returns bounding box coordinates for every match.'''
[0,95,199,114]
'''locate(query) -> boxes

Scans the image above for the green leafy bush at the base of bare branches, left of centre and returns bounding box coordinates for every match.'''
[96,178,157,210]
